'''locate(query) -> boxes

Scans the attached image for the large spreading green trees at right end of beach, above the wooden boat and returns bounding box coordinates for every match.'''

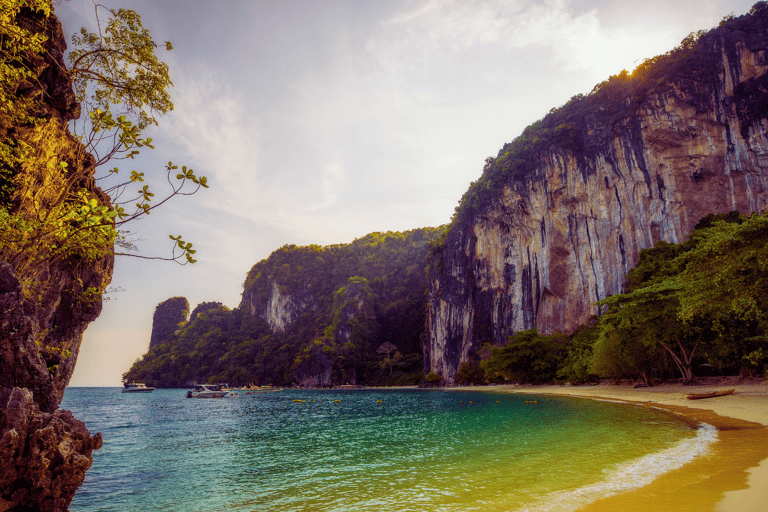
[593,212,768,383]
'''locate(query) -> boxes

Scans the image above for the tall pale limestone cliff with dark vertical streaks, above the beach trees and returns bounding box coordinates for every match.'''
[424,12,768,380]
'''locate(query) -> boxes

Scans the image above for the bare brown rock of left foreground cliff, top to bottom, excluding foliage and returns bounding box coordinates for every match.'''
[0,9,113,511]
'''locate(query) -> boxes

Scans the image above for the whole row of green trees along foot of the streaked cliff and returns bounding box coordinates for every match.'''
[455,211,768,386]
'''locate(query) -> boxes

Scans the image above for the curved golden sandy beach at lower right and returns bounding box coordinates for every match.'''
[474,378,768,512]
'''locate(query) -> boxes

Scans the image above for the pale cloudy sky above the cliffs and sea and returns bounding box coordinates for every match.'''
[55,0,756,386]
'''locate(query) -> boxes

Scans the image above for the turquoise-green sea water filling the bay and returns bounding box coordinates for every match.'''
[61,388,716,512]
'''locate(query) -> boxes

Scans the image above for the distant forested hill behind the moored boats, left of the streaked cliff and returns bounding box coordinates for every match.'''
[125,228,443,387]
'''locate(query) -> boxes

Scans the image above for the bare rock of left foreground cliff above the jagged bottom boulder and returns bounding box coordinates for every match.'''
[0,5,113,412]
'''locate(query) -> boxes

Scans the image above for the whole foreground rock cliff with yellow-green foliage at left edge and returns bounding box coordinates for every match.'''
[0,0,113,511]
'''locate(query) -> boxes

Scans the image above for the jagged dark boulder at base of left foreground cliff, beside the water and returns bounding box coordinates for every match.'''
[0,388,102,512]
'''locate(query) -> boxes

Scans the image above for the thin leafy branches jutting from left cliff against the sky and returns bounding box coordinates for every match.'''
[62,4,208,263]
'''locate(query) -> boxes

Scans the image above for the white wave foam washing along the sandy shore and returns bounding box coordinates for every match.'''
[518,423,717,512]
